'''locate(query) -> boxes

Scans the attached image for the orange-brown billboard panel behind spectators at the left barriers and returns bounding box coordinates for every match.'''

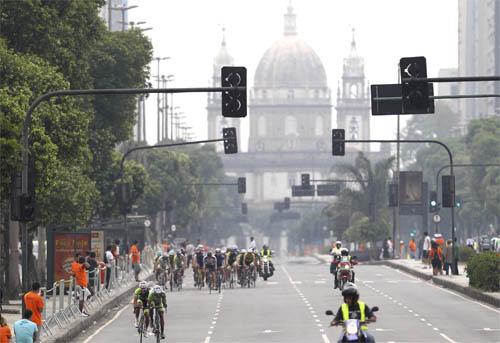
[54,233,90,280]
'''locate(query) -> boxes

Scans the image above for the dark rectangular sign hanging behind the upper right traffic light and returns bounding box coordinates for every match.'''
[370,83,434,116]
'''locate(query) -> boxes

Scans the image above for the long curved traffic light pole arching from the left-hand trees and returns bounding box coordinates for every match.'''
[19,86,247,310]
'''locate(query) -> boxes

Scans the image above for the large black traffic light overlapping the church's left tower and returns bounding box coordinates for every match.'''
[221,67,247,118]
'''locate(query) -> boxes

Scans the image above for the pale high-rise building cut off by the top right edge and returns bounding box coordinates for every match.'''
[458,0,500,126]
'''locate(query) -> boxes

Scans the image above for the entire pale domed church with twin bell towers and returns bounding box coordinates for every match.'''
[207,5,381,204]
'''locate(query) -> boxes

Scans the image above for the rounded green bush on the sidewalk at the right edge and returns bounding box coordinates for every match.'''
[466,251,500,292]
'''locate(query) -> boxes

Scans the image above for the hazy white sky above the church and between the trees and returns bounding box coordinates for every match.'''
[129,0,458,149]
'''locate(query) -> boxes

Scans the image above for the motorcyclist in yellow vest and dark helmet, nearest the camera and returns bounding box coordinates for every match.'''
[330,282,377,342]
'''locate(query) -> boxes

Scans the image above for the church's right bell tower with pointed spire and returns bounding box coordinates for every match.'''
[336,29,370,151]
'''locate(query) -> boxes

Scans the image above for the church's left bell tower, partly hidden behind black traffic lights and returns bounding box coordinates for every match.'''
[207,27,241,151]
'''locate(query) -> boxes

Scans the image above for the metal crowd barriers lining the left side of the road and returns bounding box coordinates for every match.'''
[41,251,154,336]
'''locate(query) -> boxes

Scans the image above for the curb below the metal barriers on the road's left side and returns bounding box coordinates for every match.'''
[43,275,154,343]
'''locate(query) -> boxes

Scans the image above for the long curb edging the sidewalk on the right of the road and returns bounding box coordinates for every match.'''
[382,261,500,308]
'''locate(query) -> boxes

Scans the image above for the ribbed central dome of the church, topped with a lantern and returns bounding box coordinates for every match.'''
[254,6,328,88]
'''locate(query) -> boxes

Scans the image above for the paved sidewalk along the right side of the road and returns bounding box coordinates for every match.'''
[314,254,500,308]
